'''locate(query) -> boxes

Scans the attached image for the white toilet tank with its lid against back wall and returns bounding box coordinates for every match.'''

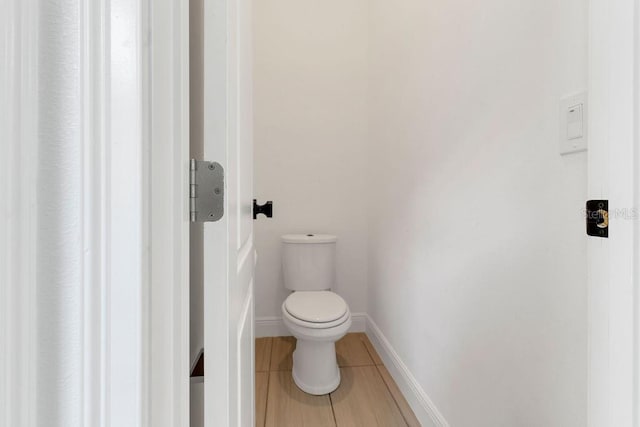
[282,234,338,291]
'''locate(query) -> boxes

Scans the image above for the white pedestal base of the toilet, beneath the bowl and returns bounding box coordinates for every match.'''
[292,338,340,395]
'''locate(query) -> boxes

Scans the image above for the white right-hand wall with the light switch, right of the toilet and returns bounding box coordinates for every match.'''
[368,0,587,427]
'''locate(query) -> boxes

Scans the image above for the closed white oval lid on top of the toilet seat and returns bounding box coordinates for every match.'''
[284,291,347,323]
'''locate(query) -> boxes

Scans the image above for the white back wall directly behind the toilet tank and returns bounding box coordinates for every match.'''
[254,0,367,318]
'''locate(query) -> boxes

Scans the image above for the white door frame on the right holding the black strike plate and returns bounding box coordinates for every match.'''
[587,0,640,427]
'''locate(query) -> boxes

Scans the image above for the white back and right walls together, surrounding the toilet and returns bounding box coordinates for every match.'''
[254,0,587,427]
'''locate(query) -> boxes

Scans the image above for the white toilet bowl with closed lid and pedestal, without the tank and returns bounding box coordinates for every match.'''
[282,291,351,395]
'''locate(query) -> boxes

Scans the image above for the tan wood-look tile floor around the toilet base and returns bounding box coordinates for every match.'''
[256,333,420,427]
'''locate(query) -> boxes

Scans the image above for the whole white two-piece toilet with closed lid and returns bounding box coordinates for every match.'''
[282,234,351,394]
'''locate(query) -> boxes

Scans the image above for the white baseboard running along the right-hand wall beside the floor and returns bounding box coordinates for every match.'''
[365,315,449,427]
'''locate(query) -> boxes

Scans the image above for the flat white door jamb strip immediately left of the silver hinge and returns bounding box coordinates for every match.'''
[144,0,191,427]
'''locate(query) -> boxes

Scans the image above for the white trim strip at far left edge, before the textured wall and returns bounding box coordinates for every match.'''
[0,0,38,427]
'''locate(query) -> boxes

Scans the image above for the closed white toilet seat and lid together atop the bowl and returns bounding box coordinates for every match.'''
[282,291,350,329]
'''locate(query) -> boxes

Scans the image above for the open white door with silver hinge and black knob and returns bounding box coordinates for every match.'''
[202,0,255,427]
